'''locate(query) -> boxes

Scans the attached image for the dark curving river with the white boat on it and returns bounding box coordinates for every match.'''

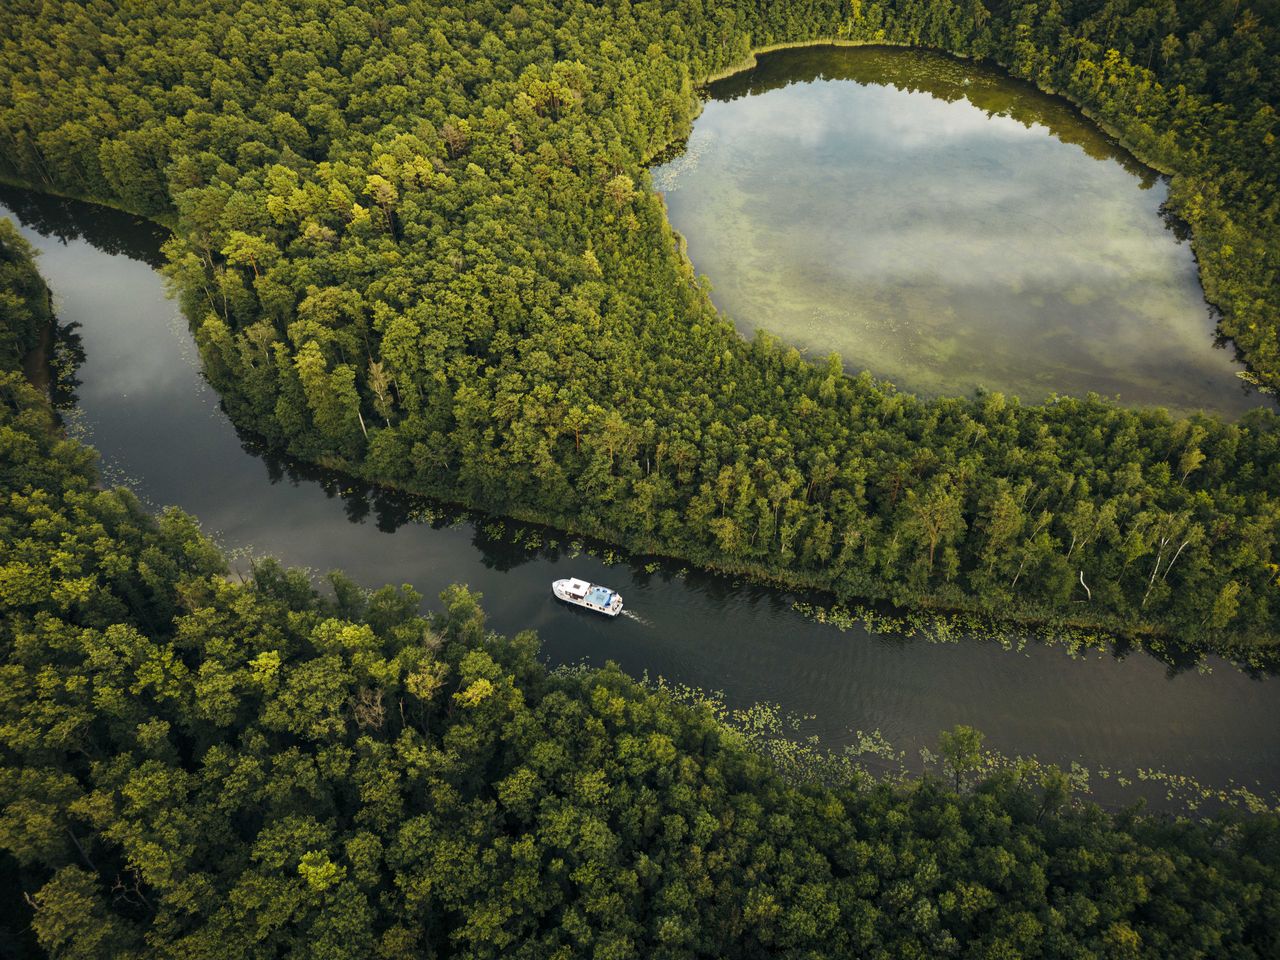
[0,181,1280,801]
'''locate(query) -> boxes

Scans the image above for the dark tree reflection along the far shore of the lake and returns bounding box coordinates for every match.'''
[708,46,1160,189]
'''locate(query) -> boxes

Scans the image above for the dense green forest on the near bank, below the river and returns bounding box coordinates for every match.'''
[0,223,1280,960]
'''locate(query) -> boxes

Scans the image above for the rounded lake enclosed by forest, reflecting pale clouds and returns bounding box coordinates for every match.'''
[654,47,1263,415]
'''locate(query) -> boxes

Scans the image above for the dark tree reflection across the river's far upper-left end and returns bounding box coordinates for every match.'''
[0,184,169,268]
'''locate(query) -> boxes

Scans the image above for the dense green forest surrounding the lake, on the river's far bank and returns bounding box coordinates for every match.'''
[0,0,1280,662]
